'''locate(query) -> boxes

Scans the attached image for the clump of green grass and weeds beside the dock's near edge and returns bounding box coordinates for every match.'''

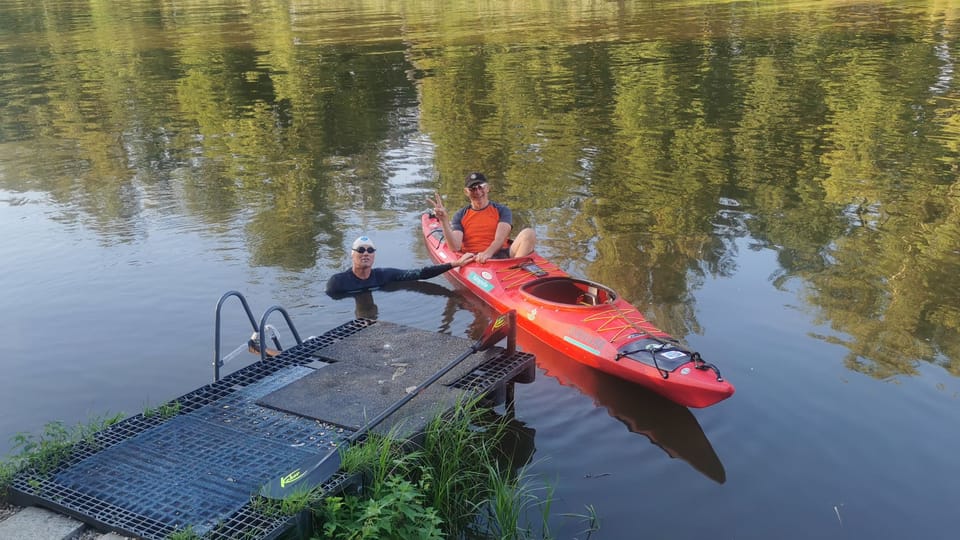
[315,400,599,540]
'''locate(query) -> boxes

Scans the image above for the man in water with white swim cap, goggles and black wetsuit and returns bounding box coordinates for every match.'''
[327,236,473,296]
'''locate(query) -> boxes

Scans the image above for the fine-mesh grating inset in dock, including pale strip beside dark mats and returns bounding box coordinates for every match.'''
[47,366,337,533]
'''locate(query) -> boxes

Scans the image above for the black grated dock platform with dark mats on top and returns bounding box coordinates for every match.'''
[10,319,536,540]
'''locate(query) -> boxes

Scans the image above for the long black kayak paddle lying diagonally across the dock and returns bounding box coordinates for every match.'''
[260,311,516,499]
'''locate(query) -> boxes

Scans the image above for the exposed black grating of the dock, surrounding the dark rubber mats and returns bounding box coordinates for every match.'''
[11,319,534,540]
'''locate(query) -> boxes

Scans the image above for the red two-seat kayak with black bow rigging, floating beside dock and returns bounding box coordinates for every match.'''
[421,212,734,407]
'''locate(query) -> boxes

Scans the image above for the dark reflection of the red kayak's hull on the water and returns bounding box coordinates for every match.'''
[517,330,727,484]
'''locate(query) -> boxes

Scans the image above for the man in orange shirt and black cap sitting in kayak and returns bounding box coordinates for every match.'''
[429,172,537,264]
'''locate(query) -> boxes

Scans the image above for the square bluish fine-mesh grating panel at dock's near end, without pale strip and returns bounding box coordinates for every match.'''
[55,415,315,534]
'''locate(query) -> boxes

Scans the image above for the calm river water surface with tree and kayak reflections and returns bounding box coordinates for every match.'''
[0,0,960,539]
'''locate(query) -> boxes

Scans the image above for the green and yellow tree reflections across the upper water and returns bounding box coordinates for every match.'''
[0,0,960,377]
